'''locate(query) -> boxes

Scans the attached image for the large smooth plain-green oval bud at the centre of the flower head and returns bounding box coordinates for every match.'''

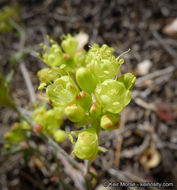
[76,67,97,94]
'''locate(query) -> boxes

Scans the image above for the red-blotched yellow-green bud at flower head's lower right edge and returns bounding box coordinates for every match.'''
[100,114,120,130]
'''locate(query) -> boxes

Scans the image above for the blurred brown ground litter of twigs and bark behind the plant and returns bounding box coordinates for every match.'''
[0,0,177,190]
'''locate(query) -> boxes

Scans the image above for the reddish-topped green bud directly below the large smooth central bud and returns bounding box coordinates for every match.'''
[76,91,92,111]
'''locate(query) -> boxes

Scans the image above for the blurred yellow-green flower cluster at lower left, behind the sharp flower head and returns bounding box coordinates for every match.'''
[4,105,66,147]
